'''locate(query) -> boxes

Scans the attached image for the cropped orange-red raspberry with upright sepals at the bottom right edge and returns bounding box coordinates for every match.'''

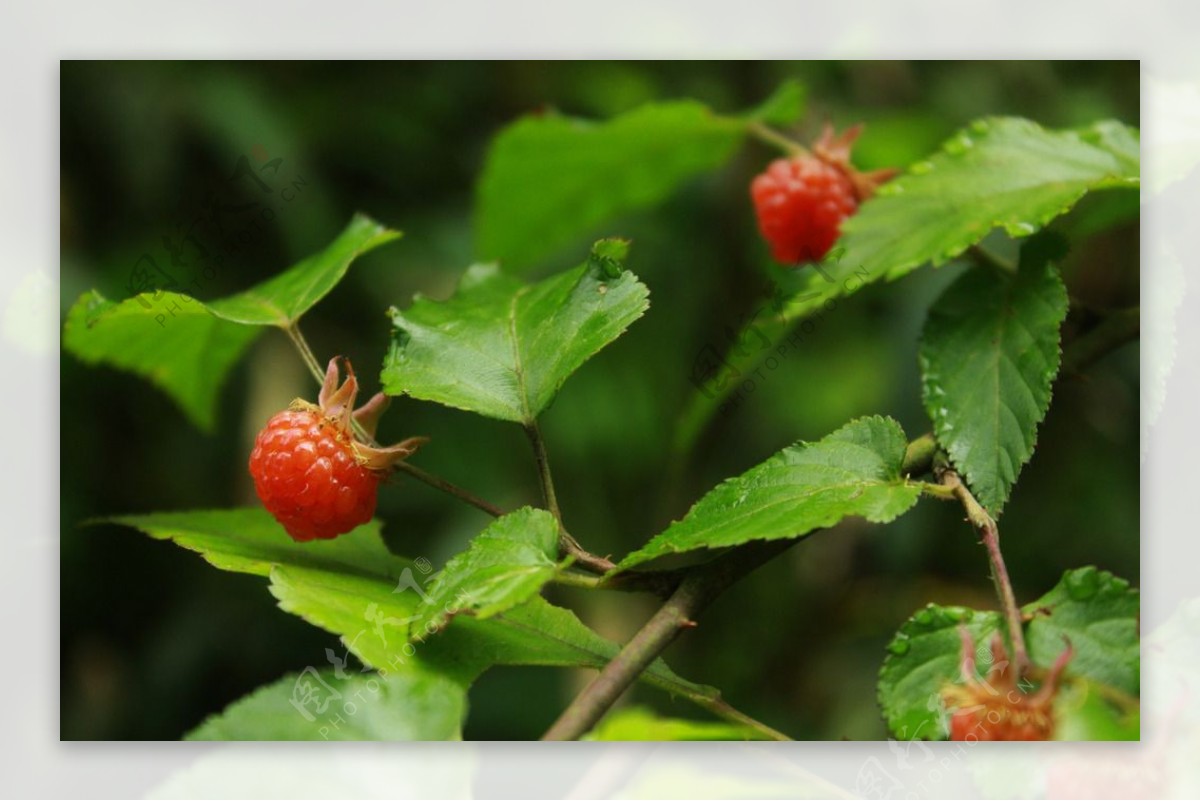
[941,627,1074,741]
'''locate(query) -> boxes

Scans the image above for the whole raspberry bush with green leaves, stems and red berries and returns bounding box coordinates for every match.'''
[64,76,1140,740]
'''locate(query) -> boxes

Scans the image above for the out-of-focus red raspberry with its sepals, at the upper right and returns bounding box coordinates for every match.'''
[750,126,894,265]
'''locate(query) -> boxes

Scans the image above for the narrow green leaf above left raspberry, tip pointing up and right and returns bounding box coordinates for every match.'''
[209,215,401,327]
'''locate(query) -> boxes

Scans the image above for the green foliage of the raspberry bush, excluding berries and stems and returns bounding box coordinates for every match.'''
[64,84,1139,739]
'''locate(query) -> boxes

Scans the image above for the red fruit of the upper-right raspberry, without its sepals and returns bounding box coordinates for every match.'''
[750,156,858,264]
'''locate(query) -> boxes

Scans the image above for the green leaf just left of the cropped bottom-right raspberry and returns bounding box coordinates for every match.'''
[877,603,1001,740]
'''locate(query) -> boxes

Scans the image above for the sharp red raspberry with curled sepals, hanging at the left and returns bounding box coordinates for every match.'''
[250,359,425,542]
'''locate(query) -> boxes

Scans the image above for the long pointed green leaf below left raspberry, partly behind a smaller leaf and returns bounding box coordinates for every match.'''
[108,508,720,733]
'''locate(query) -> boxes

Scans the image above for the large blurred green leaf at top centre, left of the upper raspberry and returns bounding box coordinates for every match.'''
[475,88,787,271]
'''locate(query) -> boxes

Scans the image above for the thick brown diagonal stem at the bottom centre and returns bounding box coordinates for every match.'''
[542,540,796,740]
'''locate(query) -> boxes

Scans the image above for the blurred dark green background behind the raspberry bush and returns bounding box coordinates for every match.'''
[60,62,1140,740]
